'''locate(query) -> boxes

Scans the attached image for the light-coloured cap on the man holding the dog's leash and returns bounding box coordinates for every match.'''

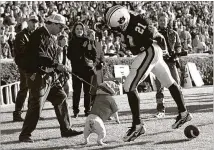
[46,13,68,28]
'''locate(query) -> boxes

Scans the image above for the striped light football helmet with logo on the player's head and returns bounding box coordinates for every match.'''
[105,5,130,31]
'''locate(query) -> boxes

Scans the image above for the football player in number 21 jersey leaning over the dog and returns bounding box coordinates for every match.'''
[105,5,192,142]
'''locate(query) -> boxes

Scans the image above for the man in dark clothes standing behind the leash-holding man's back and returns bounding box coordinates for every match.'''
[13,15,39,121]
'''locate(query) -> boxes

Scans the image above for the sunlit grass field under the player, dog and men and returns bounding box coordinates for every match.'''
[0,86,214,150]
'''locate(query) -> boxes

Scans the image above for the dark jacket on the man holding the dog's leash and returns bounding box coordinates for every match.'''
[25,26,59,73]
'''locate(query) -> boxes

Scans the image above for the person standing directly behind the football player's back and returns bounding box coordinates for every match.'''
[156,12,181,118]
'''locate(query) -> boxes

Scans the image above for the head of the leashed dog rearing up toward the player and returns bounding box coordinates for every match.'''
[97,81,119,95]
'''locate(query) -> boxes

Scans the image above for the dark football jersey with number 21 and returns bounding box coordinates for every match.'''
[123,13,155,55]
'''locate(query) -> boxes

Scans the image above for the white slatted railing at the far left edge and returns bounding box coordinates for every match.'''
[0,82,20,106]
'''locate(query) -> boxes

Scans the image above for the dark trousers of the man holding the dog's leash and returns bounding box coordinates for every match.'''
[20,73,71,137]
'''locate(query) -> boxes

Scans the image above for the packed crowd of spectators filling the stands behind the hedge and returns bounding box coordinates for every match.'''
[0,1,213,59]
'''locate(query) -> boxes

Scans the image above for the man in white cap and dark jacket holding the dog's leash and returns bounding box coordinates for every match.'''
[19,13,83,143]
